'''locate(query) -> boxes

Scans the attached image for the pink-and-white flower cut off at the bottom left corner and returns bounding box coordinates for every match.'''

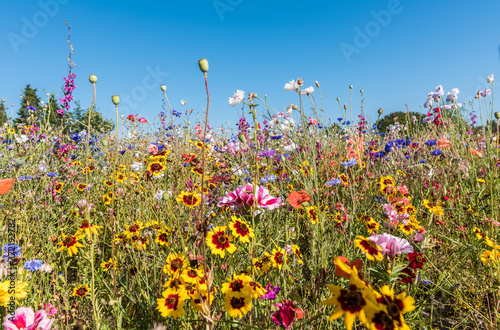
[3,307,54,330]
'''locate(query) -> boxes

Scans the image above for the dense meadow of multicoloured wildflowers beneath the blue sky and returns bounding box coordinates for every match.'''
[0,22,500,330]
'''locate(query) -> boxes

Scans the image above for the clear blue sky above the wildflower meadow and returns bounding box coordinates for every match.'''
[0,0,500,125]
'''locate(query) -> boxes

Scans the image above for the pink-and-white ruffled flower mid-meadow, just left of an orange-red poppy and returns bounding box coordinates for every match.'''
[217,183,281,210]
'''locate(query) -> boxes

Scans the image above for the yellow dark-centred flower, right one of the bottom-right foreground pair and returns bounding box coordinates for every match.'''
[375,285,415,329]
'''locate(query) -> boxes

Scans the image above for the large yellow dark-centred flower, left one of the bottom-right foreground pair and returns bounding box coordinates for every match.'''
[321,272,376,330]
